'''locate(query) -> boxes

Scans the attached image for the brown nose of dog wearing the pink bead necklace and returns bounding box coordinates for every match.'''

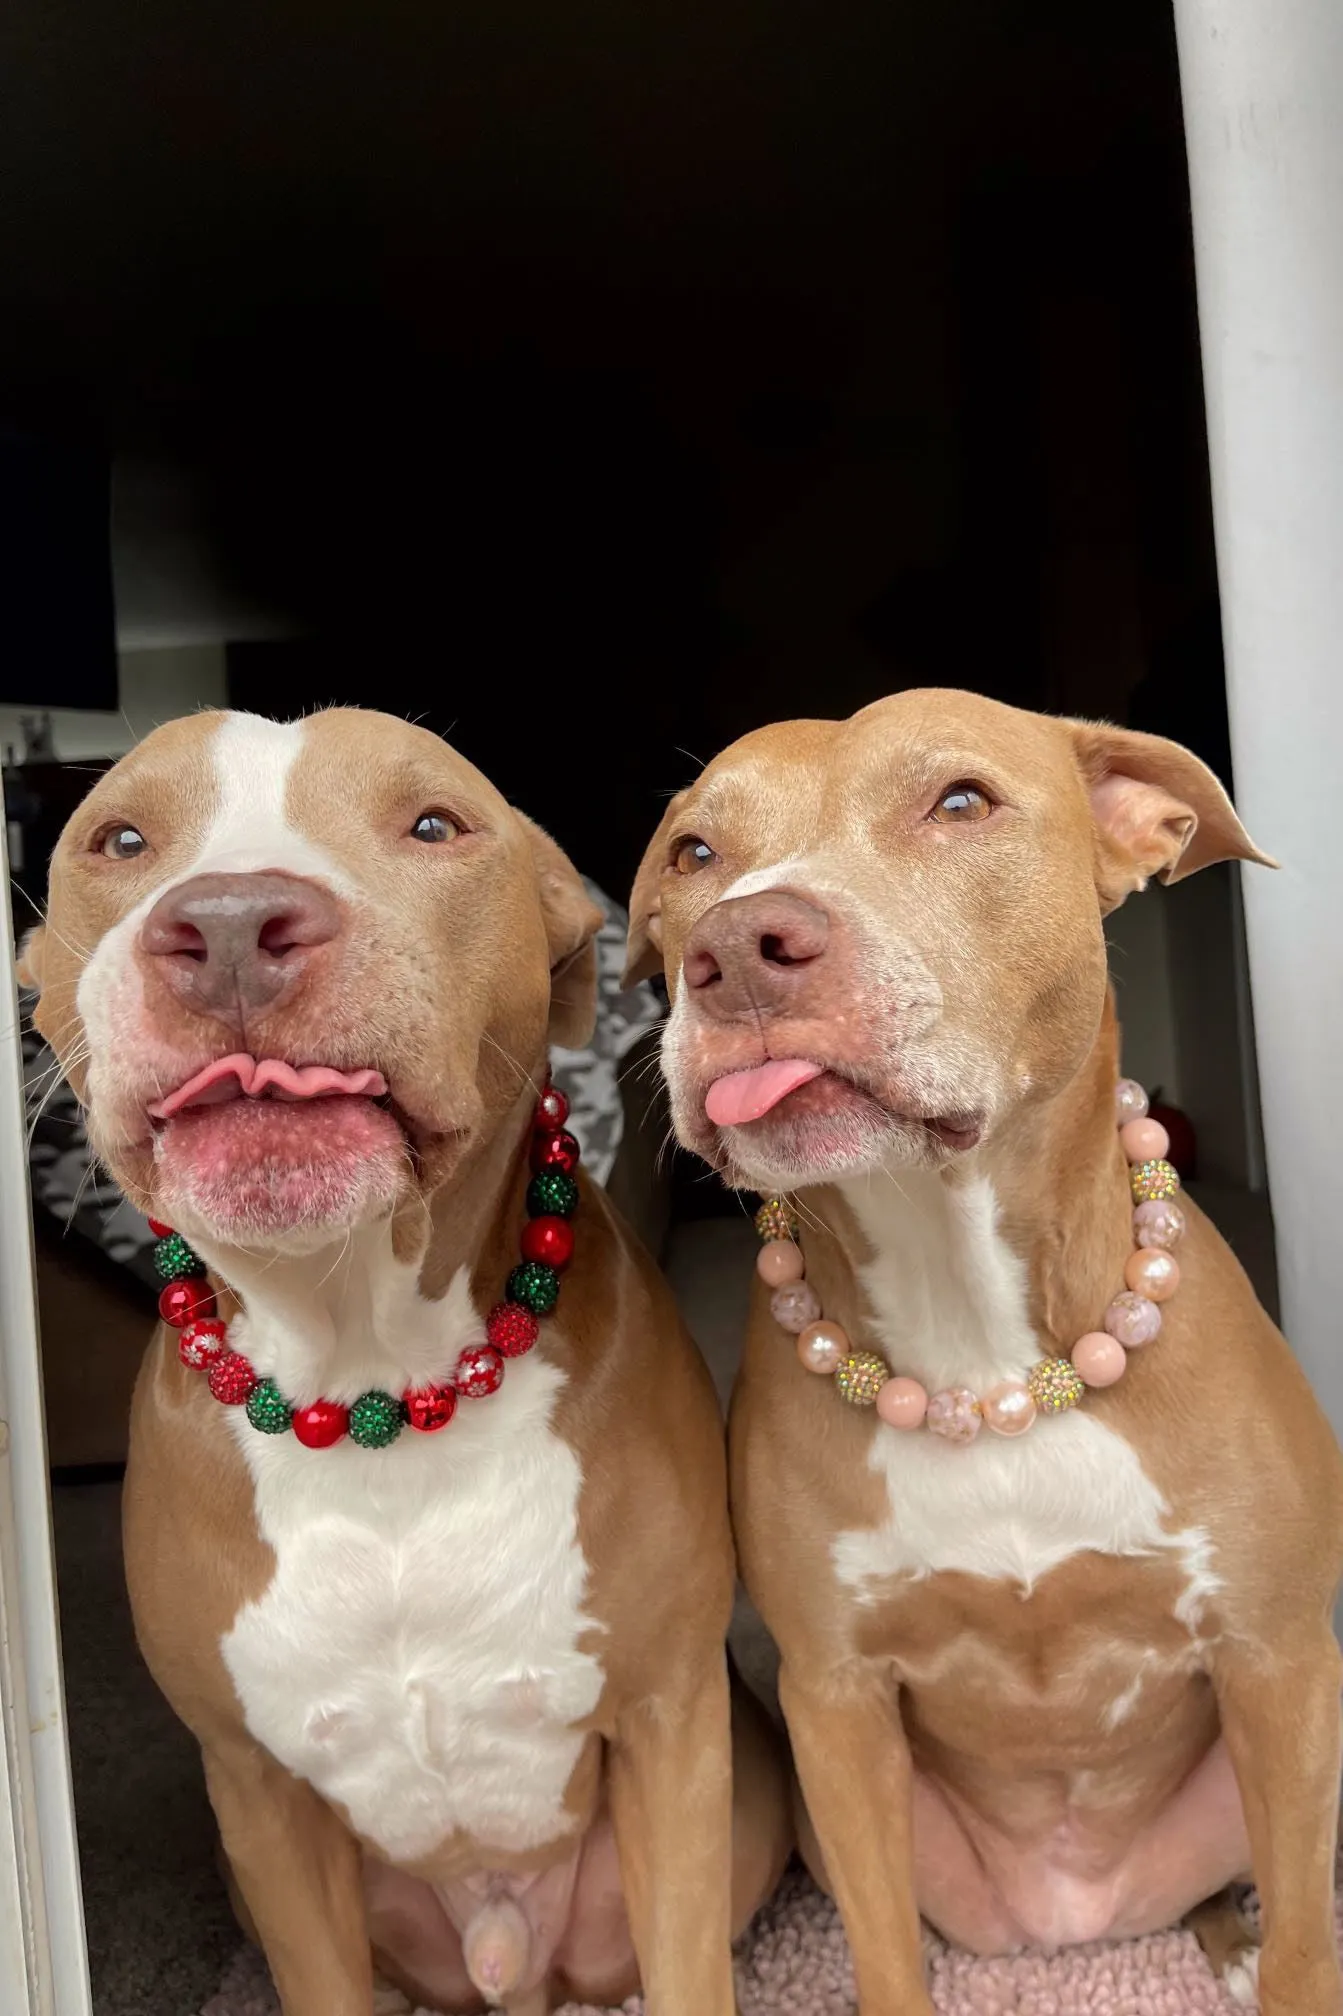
[684,889,831,1022]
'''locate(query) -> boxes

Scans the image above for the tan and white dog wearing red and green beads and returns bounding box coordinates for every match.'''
[26,710,788,2016]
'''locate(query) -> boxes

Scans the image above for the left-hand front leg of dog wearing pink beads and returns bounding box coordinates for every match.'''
[778,1659,932,2016]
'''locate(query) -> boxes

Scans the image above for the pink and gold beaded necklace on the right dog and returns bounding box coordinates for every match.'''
[756,1079,1184,1443]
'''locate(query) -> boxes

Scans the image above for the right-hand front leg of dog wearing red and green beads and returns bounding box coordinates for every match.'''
[609,1647,736,2016]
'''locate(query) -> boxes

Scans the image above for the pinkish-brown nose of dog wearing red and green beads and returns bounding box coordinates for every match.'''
[139,873,341,1024]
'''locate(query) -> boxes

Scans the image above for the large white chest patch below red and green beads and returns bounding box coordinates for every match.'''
[224,1359,603,1861]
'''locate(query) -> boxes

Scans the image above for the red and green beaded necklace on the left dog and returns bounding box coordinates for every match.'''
[149,1083,579,1450]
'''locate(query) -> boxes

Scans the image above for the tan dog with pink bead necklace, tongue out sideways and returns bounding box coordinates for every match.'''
[631,691,1343,2016]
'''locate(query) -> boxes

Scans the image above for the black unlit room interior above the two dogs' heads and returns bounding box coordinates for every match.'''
[0,0,1226,893]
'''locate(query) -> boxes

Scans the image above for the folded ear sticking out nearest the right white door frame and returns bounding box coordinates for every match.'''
[1067,722,1278,911]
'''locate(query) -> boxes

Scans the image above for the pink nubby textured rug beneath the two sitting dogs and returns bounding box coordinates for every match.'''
[202,1875,1290,2016]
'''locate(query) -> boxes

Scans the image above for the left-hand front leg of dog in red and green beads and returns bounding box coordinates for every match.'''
[204,1738,373,2016]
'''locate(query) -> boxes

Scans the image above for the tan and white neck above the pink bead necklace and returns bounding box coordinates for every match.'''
[801,1014,1131,1391]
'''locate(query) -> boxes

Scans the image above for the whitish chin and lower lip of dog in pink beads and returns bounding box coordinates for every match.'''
[686,1073,982,1191]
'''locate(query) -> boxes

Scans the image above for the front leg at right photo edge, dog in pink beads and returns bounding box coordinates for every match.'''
[1212,1625,1343,2016]
